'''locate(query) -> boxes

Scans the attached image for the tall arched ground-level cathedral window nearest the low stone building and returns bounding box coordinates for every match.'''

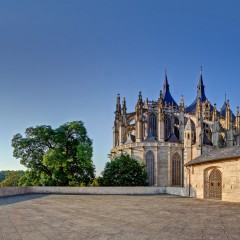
[172,153,182,186]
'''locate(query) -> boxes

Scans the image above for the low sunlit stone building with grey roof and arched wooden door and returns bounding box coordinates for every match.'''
[186,145,240,202]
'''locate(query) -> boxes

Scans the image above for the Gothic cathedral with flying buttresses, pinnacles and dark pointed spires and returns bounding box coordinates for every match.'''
[110,69,240,189]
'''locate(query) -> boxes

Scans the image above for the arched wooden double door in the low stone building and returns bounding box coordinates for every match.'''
[205,168,222,200]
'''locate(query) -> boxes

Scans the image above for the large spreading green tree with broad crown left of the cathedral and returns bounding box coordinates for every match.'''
[12,121,95,186]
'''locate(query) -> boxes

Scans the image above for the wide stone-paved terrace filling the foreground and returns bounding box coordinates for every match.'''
[0,194,240,240]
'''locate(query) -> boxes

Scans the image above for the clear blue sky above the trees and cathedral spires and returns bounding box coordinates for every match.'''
[0,0,240,173]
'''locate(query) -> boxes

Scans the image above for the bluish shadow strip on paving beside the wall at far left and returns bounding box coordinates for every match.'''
[0,194,49,206]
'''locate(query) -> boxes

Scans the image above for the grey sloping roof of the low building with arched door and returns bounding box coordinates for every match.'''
[185,145,240,166]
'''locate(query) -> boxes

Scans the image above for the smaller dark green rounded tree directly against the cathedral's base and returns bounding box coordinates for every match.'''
[99,155,147,186]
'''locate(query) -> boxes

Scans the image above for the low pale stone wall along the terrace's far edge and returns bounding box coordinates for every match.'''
[0,187,186,197]
